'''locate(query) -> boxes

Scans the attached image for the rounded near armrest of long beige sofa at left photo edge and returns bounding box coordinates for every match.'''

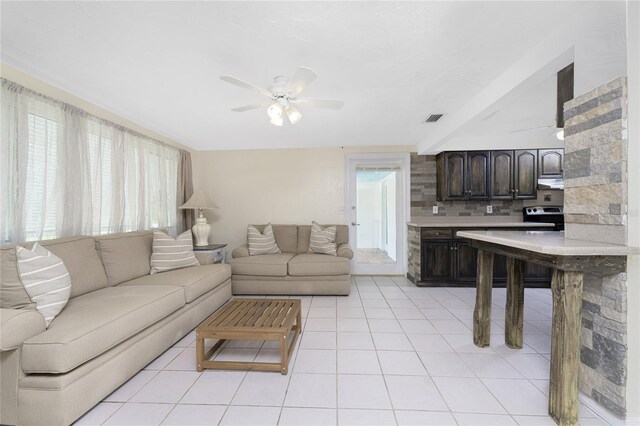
[0,309,47,351]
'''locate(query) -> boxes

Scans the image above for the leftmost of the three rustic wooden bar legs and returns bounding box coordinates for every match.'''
[473,250,493,348]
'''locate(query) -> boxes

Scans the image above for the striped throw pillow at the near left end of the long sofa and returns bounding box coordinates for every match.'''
[16,243,71,327]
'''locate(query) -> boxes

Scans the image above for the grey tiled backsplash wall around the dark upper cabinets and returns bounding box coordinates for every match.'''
[411,153,523,218]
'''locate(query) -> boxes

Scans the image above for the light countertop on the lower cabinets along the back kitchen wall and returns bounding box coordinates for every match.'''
[407,216,554,228]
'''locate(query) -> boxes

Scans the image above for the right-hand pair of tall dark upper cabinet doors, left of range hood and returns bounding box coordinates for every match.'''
[490,149,538,200]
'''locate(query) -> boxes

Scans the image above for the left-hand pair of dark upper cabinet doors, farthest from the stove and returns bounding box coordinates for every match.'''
[437,151,491,201]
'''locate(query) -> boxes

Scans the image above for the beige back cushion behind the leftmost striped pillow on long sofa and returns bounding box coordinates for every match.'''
[0,236,107,302]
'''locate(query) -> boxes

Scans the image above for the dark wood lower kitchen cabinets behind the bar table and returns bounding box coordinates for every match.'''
[417,228,551,287]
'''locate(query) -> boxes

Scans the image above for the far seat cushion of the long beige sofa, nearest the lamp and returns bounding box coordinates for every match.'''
[119,263,231,303]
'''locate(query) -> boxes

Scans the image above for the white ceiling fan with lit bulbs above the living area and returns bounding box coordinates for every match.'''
[220,67,344,126]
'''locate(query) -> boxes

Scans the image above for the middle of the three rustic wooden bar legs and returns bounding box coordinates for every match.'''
[504,257,525,349]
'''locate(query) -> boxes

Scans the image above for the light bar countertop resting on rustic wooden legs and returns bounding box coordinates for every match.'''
[456,231,640,256]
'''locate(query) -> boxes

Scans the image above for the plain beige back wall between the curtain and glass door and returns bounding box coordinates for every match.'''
[192,146,416,255]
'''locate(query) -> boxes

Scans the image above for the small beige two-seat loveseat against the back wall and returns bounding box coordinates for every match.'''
[229,225,353,295]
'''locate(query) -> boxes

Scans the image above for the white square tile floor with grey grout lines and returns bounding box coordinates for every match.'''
[77,276,606,425]
